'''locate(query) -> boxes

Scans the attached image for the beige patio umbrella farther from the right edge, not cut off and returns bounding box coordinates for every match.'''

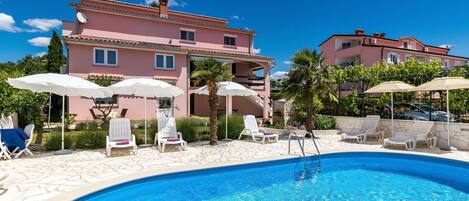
[365,81,415,135]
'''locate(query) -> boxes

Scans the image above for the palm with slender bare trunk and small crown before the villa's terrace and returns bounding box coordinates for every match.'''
[191,58,231,145]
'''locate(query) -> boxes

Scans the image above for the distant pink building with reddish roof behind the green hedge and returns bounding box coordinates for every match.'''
[319,29,468,67]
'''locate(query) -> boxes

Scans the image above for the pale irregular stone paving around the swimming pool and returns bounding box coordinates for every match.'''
[0,135,469,201]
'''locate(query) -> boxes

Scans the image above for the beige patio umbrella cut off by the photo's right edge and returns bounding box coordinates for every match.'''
[415,77,469,148]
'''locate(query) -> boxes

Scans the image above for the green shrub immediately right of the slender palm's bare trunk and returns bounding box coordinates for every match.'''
[217,115,244,139]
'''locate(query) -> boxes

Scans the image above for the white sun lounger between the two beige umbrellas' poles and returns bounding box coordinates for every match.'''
[384,121,434,150]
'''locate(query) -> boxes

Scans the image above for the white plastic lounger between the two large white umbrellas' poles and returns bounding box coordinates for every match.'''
[106,118,137,156]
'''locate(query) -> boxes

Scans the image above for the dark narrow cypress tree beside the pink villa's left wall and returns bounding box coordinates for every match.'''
[46,31,65,73]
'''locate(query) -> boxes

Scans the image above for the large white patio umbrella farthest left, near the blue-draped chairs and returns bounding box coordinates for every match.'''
[7,73,112,154]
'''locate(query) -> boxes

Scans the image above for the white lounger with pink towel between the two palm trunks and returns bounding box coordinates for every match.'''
[238,115,278,144]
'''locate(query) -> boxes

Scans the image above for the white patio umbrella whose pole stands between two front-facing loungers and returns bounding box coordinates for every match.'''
[108,78,184,145]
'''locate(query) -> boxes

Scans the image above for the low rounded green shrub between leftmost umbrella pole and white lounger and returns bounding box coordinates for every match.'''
[75,130,107,149]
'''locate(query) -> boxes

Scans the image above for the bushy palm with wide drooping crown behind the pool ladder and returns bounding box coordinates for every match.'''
[282,49,337,133]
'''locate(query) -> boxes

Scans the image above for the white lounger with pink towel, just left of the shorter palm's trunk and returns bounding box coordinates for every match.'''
[155,117,187,152]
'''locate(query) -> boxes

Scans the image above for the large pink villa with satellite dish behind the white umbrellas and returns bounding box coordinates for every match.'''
[62,0,274,121]
